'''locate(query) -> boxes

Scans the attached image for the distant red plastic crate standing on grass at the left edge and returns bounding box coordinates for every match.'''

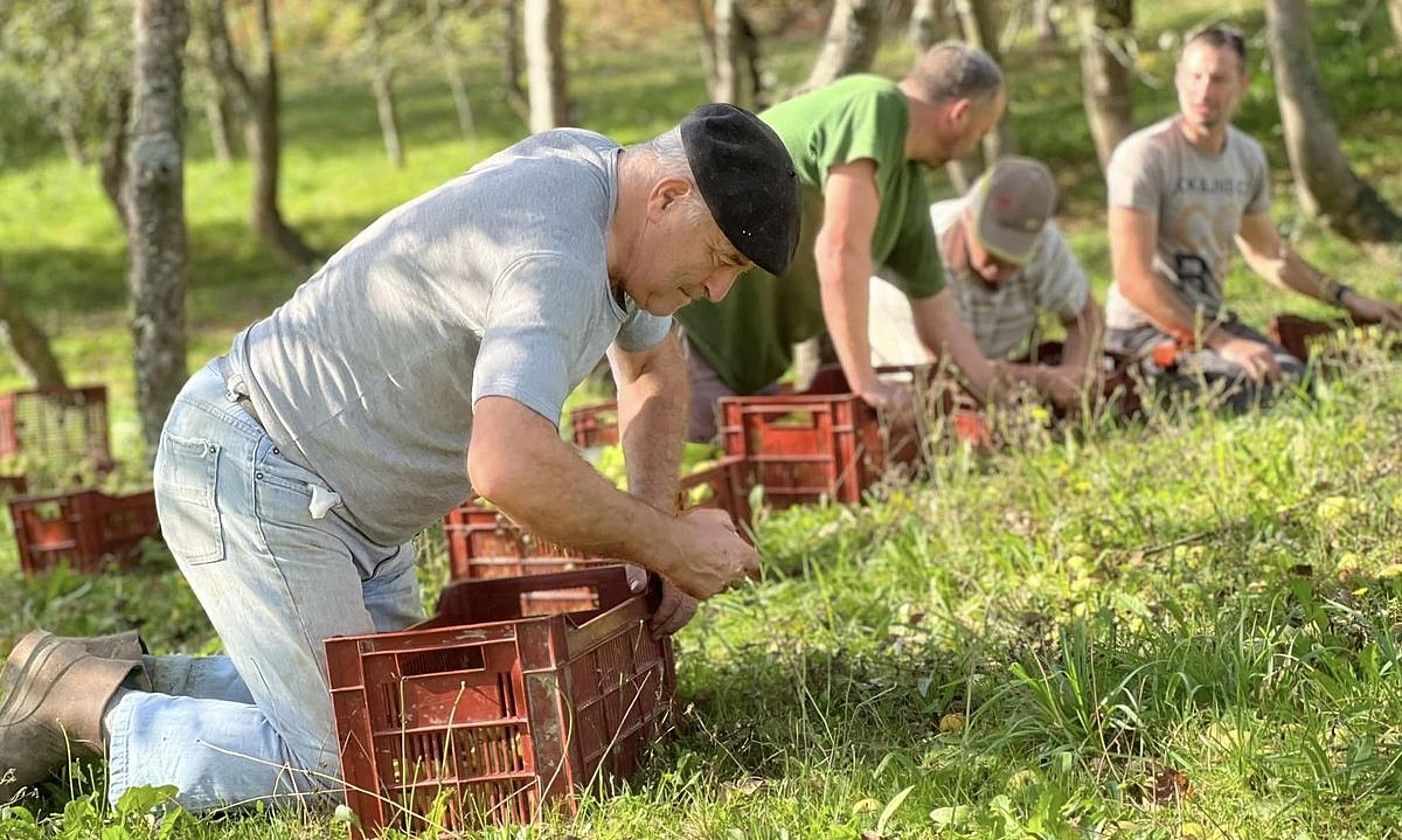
[0,386,112,467]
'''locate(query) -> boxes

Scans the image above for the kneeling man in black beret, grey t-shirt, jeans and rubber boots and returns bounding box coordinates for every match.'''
[0,105,799,809]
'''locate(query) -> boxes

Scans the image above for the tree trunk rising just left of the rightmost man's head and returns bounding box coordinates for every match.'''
[1077,0,1134,171]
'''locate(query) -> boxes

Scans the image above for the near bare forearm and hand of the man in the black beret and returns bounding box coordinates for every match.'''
[467,397,758,597]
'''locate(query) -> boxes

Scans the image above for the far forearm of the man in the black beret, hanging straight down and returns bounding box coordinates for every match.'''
[608,331,688,513]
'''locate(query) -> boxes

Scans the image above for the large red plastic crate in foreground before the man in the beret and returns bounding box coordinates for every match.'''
[327,567,676,837]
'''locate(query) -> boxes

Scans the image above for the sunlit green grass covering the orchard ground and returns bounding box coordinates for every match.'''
[0,0,1402,840]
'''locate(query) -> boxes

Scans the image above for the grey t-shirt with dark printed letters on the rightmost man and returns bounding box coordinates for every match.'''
[1105,116,1270,330]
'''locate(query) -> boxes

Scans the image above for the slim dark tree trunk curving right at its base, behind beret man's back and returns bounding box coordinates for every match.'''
[247,0,318,271]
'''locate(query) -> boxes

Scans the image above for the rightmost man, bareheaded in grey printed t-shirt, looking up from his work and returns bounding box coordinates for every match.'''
[1106,25,1402,407]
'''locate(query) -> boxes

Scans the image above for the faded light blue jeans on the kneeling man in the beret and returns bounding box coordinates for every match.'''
[104,363,422,811]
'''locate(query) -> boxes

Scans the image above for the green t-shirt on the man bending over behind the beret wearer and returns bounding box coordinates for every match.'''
[676,74,945,394]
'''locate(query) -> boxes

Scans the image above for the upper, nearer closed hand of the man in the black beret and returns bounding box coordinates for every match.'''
[658,508,760,600]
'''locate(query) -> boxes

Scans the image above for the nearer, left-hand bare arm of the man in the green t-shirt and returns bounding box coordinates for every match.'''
[815,158,885,408]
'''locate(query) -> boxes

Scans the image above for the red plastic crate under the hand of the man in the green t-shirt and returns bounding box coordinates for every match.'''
[718,366,932,508]
